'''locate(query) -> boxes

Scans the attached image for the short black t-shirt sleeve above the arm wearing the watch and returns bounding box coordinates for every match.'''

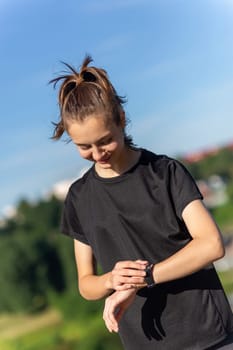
[169,160,203,220]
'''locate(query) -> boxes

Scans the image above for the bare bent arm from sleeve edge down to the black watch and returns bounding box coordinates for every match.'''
[153,200,225,283]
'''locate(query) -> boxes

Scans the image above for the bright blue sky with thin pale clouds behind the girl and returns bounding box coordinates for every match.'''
[0,0,233,214]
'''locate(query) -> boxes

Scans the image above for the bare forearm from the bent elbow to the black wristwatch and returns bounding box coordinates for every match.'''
[153,232,224,283]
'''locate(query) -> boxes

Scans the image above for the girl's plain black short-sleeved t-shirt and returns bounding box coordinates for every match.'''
[62,150,233,350]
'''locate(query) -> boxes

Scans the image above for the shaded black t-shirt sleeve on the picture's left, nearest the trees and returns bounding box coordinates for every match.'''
[60,191,89,244]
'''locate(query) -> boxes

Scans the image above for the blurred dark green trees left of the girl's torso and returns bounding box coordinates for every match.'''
[0,198,66,312]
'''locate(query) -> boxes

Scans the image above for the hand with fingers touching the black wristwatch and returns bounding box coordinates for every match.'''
[108,260,148,290]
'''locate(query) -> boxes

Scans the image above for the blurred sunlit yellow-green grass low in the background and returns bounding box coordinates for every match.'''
[0,269,233,350]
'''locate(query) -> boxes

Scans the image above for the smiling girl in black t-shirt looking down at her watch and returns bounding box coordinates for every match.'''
[51,57,233,350]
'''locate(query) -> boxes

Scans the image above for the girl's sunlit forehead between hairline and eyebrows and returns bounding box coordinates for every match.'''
[67,115,117,144]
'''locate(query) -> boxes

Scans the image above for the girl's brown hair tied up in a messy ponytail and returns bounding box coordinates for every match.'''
[49,56,134,146]
